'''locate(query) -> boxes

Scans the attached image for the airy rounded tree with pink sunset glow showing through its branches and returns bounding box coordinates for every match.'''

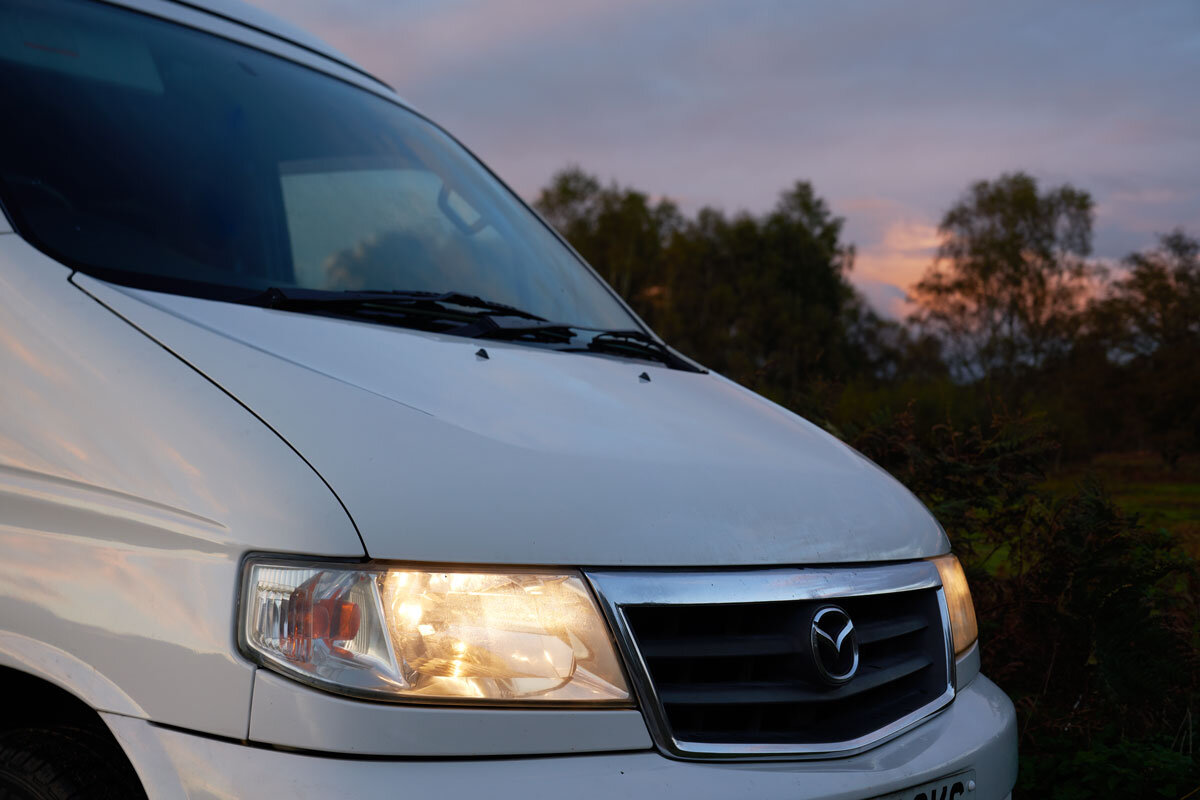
[911,173,1097,385]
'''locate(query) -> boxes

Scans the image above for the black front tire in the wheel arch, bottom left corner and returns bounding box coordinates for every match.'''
[0,727,145,800]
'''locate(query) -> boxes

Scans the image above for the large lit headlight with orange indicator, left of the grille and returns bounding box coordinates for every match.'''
[240,560,630,705]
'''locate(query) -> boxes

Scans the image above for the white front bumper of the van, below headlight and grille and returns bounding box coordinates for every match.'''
[104,675,1016,800]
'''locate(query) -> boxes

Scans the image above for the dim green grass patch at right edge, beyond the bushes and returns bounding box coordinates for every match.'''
[1045,452,1200,558]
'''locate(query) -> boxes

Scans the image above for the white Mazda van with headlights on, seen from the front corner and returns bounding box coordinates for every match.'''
[0,0,1016,800]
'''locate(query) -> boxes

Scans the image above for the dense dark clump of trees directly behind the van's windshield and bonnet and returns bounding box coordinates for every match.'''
[536,167,886,407]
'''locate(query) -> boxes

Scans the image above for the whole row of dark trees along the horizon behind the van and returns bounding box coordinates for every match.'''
[536,168,1200,464]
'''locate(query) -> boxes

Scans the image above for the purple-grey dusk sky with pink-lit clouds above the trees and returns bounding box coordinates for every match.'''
[251,0,1200,315]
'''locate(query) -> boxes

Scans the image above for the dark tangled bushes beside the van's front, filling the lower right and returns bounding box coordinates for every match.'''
[835,410,1200,798]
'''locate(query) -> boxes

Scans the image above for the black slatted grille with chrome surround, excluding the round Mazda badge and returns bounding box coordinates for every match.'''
[589,563,953,758]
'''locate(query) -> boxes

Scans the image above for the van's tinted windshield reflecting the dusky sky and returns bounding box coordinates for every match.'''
[0,0,637,329]
